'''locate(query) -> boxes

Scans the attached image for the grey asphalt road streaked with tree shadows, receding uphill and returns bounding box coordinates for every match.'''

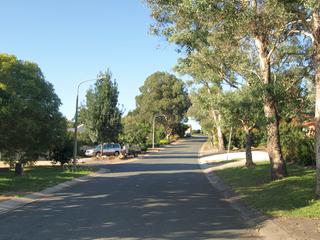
[0,138,257,240]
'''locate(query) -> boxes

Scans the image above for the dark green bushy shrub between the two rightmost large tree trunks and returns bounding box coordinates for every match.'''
[280,122,316,165]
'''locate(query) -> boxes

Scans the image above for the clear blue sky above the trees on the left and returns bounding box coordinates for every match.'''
[0,0,200,128]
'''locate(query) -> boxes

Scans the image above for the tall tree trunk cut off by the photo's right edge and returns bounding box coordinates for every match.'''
[312,11,320,198]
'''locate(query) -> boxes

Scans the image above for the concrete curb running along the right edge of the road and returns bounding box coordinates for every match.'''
[198,144,296,240]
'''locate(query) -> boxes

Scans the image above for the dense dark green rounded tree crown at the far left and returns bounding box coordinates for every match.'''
[0,54,64,171]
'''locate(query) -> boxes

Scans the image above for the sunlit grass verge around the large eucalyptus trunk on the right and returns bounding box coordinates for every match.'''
[215,163,320,218]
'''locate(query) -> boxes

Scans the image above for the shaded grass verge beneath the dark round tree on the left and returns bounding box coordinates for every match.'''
[0,166,95,196]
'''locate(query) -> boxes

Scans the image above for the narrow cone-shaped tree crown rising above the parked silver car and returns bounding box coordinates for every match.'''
[81,71,122,143]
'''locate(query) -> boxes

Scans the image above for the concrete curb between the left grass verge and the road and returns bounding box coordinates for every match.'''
[0,169,110,215]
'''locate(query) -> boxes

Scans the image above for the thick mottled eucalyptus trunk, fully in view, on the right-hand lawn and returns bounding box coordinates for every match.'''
[255,36,287,180]
